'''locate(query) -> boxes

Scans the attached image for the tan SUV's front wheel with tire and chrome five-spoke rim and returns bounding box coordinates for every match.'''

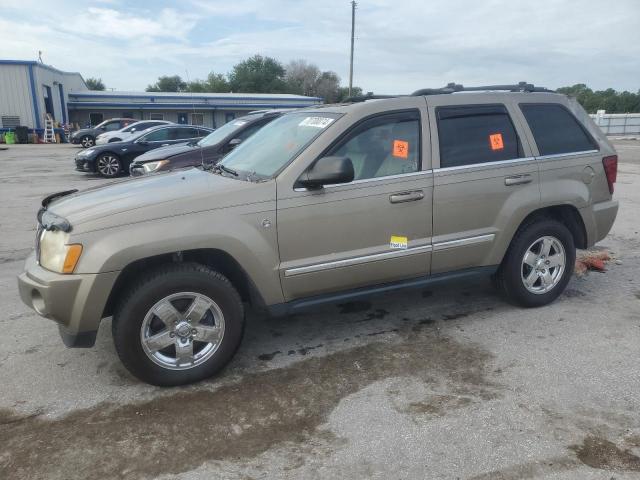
[112,263,244,386]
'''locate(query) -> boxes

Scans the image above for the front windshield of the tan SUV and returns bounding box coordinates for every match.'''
[220,112,339,179]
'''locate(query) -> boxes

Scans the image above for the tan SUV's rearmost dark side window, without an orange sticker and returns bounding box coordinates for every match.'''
[520,103,598,155]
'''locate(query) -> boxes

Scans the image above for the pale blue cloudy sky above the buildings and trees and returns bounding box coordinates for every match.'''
[0,0,640,94]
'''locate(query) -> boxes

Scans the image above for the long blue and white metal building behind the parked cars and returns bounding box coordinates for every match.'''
[0,60,322,134]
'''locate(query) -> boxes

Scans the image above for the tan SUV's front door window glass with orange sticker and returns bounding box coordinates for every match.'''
[329,111,420,180]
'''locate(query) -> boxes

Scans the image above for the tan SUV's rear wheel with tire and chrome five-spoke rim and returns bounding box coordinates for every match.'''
[495,219,576,307]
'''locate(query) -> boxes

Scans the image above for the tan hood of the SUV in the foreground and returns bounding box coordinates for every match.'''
[48,168,262,233]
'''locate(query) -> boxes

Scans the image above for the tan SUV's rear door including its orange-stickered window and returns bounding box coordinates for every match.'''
[426,94,540,274]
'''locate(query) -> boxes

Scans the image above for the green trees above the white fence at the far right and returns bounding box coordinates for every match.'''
[557,83,640,113]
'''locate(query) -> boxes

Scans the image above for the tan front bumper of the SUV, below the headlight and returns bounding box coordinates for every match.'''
[18,254,119,347]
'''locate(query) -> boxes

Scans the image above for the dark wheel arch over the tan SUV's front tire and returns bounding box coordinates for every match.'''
[102,248,265,318]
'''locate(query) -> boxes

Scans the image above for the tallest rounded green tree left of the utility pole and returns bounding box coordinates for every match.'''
[228,55,286,93]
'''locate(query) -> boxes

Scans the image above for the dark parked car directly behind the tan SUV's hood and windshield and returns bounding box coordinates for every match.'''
[129,111,283,176]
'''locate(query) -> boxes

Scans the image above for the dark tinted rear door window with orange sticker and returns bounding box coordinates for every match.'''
[436,105,522,168]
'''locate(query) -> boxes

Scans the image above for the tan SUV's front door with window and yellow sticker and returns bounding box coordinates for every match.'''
[278,109,433,301]
